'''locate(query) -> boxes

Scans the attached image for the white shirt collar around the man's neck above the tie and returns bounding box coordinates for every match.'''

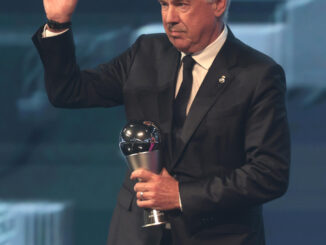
[181,25,228,70]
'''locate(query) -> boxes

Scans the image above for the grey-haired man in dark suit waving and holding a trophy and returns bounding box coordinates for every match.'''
[33,0,290,245]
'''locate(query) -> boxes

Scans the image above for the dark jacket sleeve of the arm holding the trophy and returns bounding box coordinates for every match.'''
[179,65,290,217]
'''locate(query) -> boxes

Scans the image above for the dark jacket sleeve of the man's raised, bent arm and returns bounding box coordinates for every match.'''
[32,27,138,108]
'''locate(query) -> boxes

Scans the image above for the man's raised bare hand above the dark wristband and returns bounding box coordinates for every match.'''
[43,0,78,23]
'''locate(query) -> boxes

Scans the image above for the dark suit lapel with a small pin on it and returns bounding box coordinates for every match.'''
[172,29,236,168]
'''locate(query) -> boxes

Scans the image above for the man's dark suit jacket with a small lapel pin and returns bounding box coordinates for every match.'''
[33,26,290,245]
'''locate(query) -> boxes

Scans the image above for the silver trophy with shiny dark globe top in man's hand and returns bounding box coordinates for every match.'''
[119,121,166,227]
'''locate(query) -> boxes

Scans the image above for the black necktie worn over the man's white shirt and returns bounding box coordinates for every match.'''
[173,55,196,128]
